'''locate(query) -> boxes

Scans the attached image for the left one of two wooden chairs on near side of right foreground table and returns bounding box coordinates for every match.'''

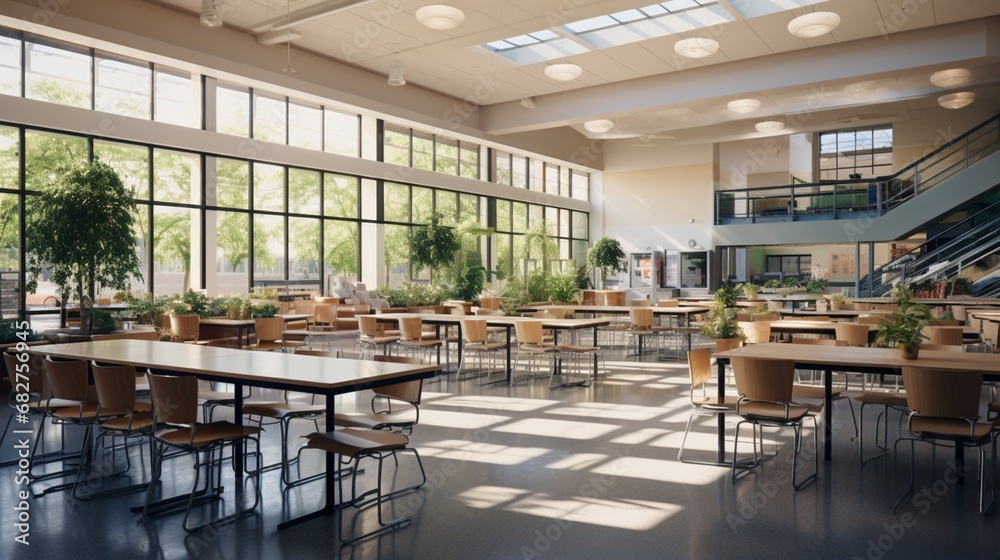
[731,357,819,490]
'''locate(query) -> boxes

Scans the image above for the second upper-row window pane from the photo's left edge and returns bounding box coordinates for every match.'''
[24,41,93,109]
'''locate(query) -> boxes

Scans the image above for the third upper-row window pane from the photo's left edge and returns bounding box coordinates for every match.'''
[94,55,153,119]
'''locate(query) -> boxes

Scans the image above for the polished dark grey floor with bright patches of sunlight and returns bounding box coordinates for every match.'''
[0,348,1000,560]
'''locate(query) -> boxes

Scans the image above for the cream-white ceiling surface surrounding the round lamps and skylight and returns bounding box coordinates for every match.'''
[149,0,1000,144]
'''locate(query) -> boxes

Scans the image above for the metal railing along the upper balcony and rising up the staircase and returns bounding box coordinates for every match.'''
[715,114,1000,225]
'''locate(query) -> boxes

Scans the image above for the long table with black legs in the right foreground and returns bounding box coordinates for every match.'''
[716,343,1000,462]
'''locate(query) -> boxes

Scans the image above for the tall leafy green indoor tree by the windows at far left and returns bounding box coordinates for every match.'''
[25,159,141,333]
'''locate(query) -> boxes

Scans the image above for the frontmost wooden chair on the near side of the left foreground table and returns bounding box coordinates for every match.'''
[142,373,261,532]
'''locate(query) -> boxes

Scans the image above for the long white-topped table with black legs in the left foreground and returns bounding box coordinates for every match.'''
[28,340,439,529]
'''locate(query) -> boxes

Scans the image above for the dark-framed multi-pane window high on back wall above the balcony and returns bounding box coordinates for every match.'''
[819,125,892,181]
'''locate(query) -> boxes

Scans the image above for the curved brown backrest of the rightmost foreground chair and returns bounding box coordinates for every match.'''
[903,367,983,419]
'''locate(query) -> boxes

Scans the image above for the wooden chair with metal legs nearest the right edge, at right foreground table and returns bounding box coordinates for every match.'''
[893,367,996,513]
